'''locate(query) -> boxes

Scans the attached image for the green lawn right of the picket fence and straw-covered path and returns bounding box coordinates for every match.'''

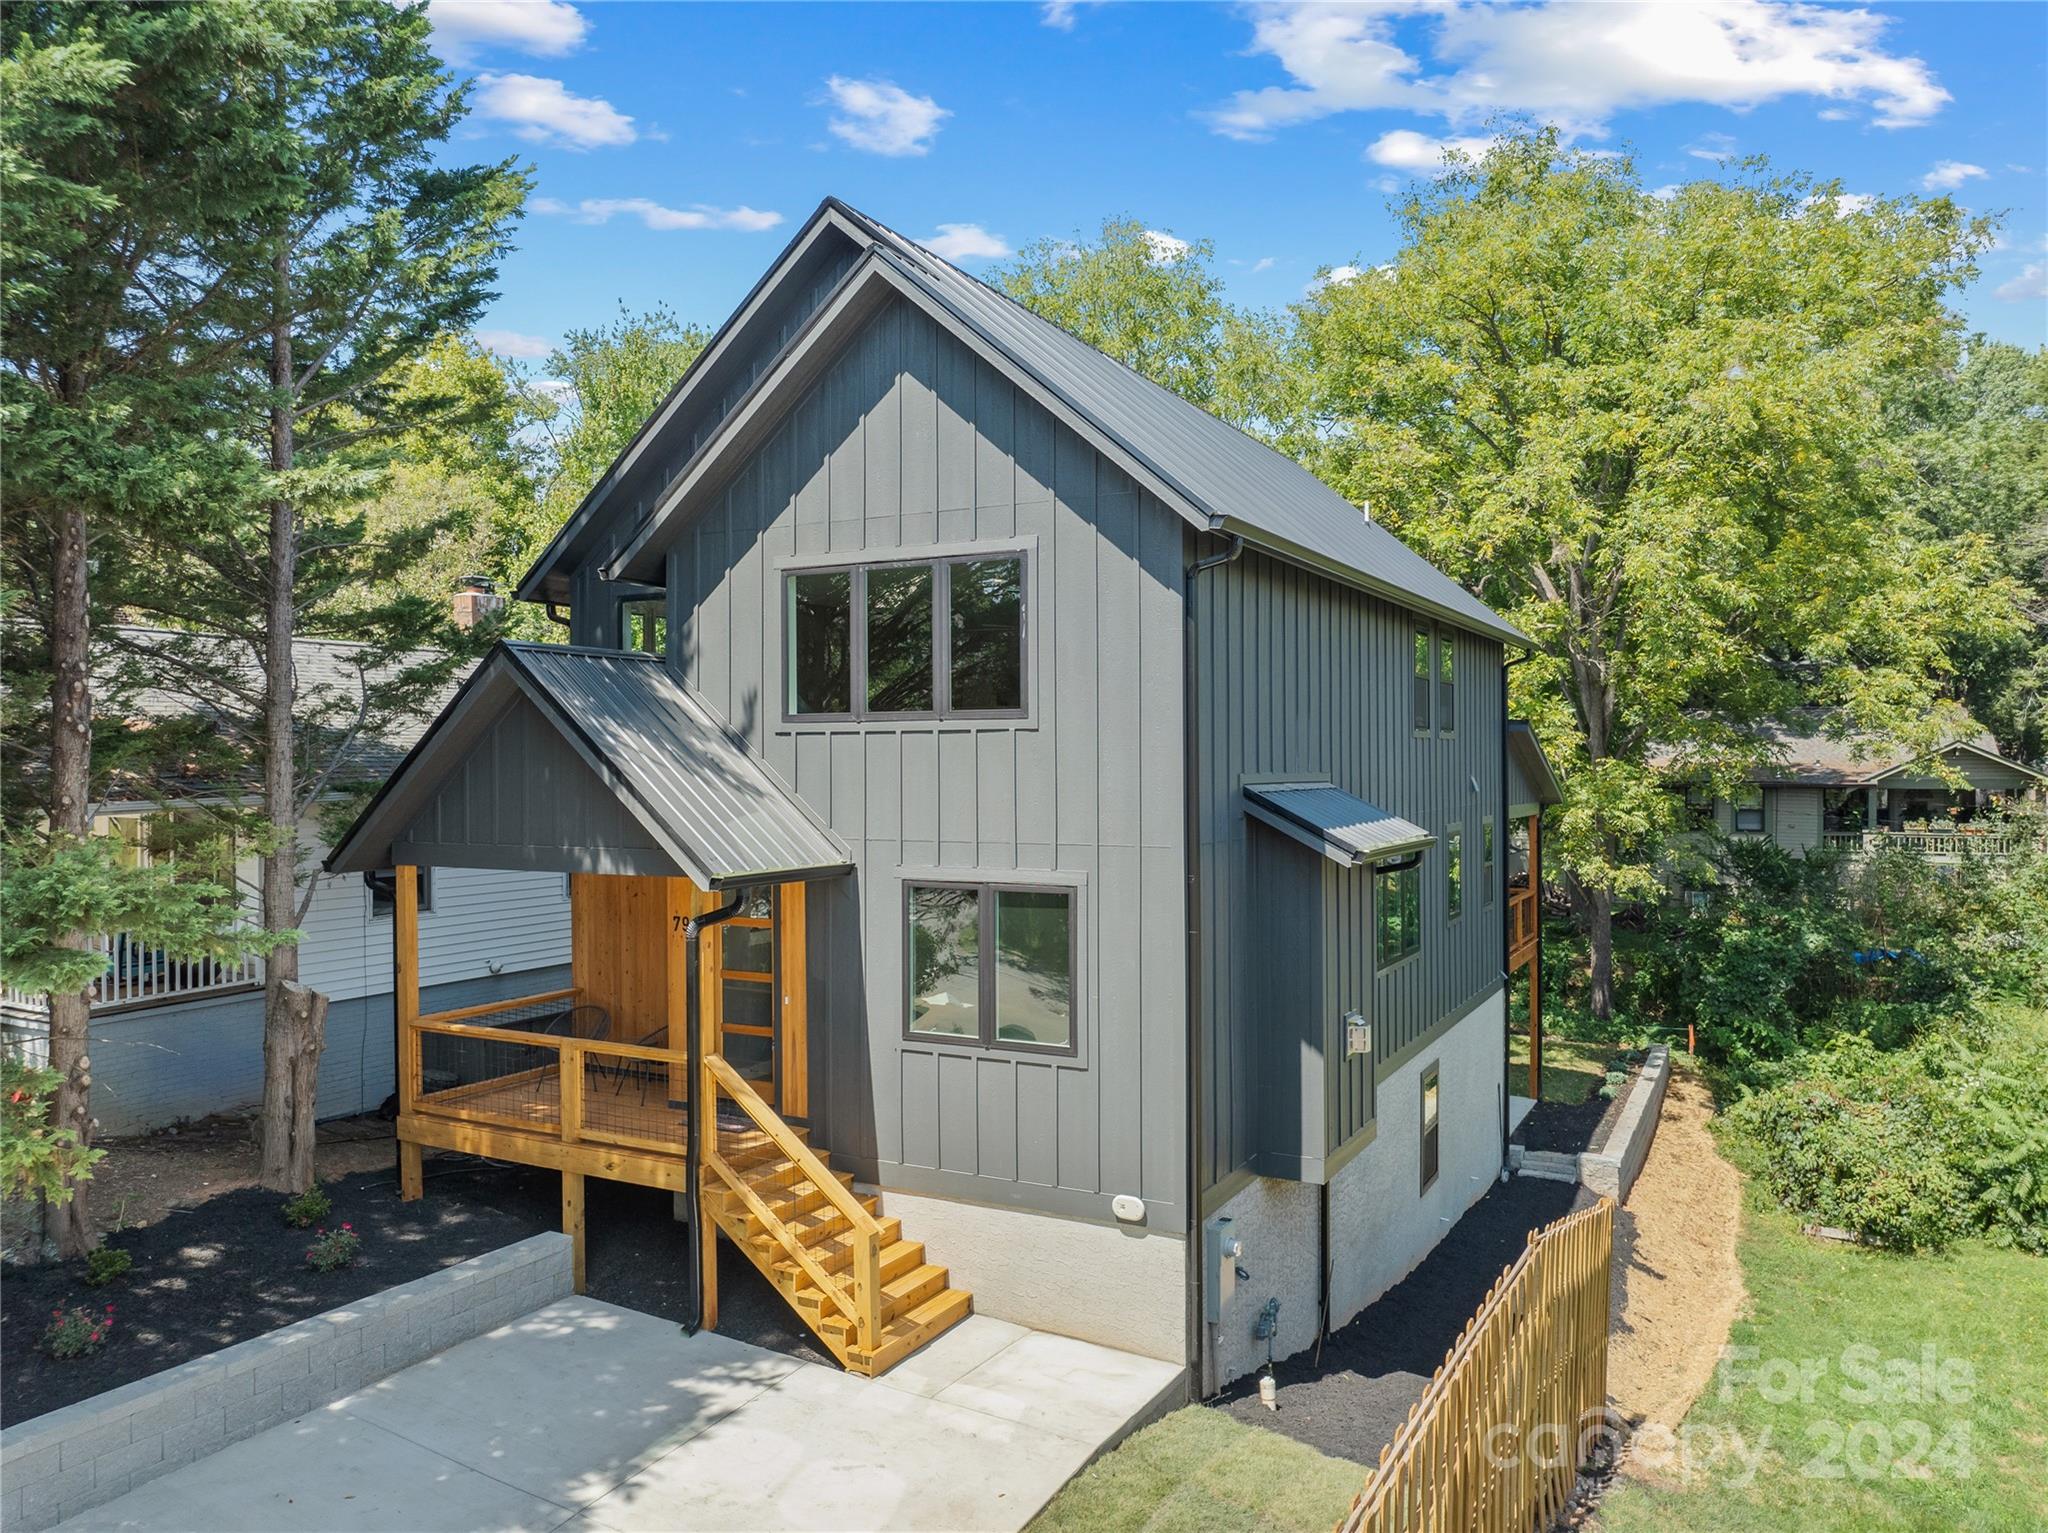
[1599,1208,2048,1533]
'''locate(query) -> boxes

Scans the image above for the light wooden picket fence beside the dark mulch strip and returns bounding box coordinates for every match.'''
[1337,1197,1614,1533]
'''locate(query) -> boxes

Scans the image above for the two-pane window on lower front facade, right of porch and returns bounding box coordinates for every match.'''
[903,884,1075,1054]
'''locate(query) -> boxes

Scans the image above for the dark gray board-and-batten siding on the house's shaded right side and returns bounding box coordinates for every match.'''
[1194,551,1505,1201]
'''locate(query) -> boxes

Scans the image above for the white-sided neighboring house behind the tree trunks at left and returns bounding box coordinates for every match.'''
[0,628,569,1134]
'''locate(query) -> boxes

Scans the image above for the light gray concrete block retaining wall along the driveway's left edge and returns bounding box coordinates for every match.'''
[0,1234,573,1533]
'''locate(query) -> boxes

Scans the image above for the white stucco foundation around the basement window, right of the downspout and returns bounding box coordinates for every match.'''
[1329,991,1505,1330]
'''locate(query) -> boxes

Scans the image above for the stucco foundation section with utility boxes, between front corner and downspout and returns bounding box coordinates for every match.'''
[1204,1177,1323,1394]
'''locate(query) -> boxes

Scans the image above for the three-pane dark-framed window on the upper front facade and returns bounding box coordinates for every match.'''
[784,555,1024,718]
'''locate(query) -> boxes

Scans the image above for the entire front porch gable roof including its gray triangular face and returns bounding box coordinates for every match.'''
[326,643,852,888]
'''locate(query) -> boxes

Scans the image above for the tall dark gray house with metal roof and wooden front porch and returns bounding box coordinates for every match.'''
[330,201,1554,1388]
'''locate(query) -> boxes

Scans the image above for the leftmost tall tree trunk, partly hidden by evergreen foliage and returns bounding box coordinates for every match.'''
[49,506,98,1257]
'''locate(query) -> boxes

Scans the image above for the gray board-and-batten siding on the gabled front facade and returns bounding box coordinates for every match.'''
[606,303,1188,1232]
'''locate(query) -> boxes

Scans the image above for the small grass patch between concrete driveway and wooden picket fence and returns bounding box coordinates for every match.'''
[1030,1406,1366,1533]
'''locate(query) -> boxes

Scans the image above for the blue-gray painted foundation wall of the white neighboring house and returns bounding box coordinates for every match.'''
[34,964,569,1134]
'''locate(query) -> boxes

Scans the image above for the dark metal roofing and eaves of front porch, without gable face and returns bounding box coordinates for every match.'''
[328,643,852,888]
